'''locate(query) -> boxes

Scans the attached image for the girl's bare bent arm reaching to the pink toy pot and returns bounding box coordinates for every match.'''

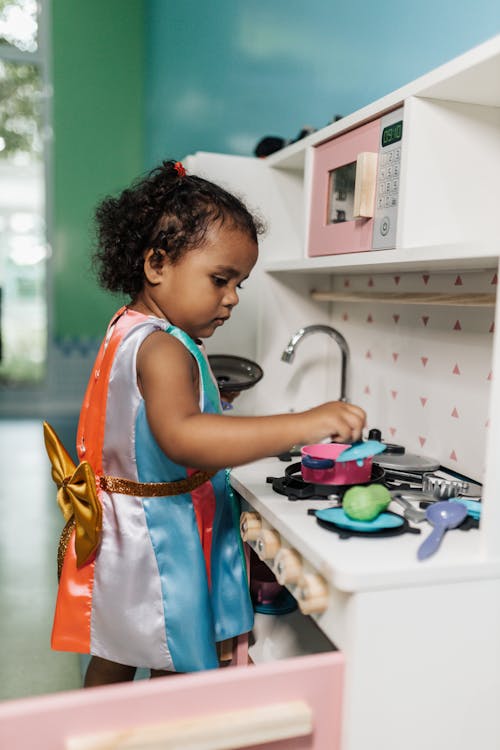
[137,331,365,469]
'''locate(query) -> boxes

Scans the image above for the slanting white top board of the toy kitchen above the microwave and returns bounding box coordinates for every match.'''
[266,35,500,170]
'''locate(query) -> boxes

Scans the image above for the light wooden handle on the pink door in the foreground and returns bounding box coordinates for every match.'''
[64,701,313,750]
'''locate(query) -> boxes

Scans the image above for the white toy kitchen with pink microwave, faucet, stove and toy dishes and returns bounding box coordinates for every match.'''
[3,37,500,750]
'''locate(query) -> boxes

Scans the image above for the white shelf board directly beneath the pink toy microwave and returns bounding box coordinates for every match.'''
[264,241,500,274]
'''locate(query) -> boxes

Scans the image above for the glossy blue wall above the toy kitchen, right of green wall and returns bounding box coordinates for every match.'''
[145,0,500,167]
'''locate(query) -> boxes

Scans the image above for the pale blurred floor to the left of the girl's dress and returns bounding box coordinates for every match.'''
[0,420,81,700]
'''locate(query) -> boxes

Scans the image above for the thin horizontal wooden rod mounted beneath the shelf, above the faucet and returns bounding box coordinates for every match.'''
[311,289,496,307]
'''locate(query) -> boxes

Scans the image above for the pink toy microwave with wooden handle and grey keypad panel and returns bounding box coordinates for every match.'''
[308,107,404,256]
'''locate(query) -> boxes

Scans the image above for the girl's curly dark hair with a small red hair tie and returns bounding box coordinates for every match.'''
[92,160,264,298]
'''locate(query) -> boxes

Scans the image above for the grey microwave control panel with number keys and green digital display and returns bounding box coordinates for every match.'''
[372,107,403,250]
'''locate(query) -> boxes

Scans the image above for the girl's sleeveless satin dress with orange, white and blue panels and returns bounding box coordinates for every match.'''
[52,308,253,672]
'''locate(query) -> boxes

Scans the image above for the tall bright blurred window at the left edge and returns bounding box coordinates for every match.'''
[0,0,49,384]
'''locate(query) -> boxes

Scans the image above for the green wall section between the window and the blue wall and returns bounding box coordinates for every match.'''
[51,0,144,339]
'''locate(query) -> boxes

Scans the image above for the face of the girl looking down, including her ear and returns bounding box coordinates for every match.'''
[144,224,258,339]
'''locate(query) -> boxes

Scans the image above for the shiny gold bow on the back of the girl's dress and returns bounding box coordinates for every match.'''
[43,422,102,568]
